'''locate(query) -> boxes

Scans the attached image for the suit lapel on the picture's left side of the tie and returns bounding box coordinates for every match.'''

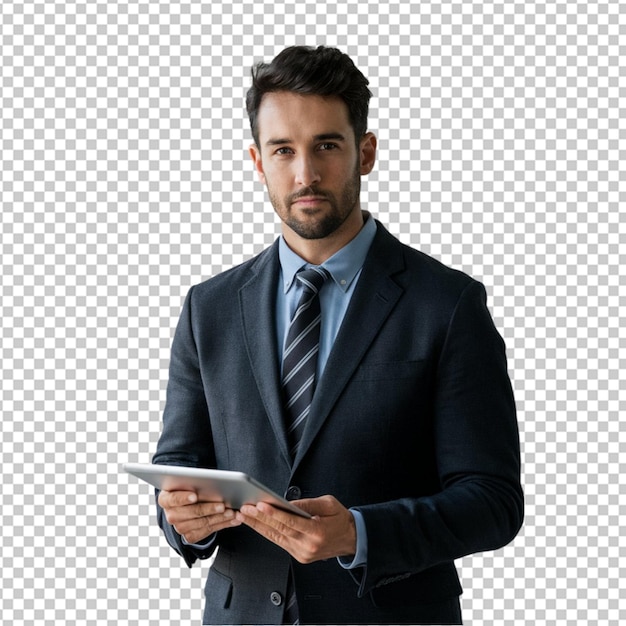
[239,244,291,464]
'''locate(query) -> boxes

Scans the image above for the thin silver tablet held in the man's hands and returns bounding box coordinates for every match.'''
[124,463,311,517]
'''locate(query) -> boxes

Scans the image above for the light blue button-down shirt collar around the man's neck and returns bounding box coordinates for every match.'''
[278,212,376,293]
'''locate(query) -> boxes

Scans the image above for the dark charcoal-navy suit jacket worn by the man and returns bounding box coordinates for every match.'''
[153,217,523,624]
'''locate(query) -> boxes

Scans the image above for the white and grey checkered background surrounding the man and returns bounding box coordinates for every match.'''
[0,0,626,625]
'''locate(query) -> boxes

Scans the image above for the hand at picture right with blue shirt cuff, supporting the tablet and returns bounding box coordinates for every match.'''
[236,496,356,563]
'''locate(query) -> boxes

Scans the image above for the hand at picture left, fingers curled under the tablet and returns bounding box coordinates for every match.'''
[159,491,241,543]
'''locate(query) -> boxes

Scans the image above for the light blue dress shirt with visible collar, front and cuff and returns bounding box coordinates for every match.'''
[276,214,376,569]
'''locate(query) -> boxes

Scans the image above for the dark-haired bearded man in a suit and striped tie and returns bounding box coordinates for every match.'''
[153,47,523,624]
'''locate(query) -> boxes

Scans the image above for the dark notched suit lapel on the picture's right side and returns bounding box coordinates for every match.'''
[294,224,404,469]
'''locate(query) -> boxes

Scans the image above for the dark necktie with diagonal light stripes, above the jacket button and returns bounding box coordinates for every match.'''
[283,267,330,458]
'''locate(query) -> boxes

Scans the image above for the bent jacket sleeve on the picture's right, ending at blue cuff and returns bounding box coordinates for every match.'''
[355,281,523,595]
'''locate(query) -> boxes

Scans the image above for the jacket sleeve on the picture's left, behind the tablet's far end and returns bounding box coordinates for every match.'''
[152,288,217,567]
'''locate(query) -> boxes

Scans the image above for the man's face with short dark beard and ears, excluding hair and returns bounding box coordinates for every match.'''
[250,92,375,239]
